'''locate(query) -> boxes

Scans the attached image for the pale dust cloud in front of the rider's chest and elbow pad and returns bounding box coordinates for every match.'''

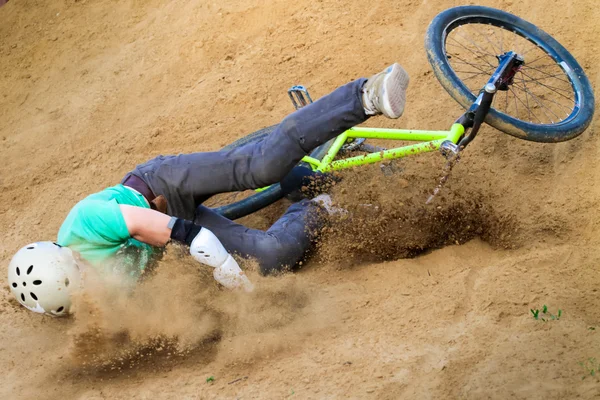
[68,245,333,370]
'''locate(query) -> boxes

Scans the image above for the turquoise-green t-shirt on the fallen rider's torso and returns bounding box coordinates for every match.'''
[57,185,156,276]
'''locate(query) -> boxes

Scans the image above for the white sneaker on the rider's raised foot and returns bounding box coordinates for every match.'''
[362,63,410,119]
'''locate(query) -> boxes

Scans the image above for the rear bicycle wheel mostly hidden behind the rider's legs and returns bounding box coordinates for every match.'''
[213,125,334,220]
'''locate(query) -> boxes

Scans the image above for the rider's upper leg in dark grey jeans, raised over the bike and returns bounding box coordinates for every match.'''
[133,79,368,219]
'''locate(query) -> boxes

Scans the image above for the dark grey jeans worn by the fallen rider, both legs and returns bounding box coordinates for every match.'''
[131,78,368,274]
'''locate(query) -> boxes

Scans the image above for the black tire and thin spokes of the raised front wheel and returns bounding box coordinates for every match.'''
[425,6,594,142]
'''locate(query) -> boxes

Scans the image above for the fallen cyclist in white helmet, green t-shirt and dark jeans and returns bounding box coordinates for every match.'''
[8,64,409,315]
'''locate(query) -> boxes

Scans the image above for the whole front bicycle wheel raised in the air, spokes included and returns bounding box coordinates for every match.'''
[425,6,594,142]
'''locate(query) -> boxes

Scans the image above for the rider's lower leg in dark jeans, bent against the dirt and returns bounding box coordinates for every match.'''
[196,200,325,275]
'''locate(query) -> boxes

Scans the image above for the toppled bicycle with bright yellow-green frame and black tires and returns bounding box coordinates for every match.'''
[209,6,595,219]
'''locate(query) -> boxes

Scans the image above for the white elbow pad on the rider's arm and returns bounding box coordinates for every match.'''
[190,228,254,292]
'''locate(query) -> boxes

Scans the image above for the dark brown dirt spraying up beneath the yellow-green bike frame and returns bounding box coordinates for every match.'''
[318,157,519,263]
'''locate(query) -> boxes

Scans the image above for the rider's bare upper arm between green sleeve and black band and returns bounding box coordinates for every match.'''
[119,204,171,247]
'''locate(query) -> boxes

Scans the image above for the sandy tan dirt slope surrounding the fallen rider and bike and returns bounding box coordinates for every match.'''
[0,0,600,399]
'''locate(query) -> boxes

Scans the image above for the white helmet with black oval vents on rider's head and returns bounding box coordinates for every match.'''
[8,242,80,316]
